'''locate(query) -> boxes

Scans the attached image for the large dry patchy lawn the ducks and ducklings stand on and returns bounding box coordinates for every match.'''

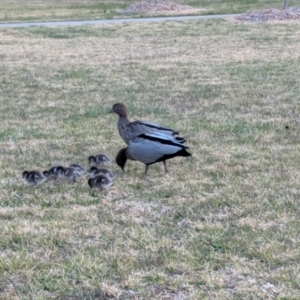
[0,20,300,300]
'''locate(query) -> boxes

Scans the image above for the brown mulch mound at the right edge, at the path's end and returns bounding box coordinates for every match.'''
[236,7,300,23]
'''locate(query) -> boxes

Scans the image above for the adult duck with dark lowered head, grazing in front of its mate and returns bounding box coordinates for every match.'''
[116,134,191,174]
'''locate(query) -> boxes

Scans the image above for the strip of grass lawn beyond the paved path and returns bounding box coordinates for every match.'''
[0,0,300,23]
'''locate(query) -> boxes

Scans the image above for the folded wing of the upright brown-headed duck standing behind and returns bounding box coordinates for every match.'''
[129,120,179,137]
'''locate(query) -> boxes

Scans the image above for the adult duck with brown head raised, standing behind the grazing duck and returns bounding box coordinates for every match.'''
[109,103,185,145]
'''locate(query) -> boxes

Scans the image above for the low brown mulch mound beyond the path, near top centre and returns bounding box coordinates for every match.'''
[124,2,199,14]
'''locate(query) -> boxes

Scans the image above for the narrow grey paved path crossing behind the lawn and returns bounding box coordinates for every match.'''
[0,14,239,28]
